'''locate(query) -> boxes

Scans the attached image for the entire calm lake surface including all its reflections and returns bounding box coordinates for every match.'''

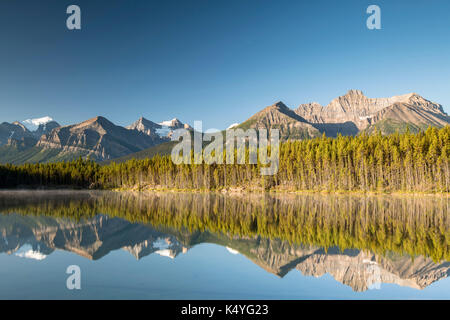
[0,191,450,299]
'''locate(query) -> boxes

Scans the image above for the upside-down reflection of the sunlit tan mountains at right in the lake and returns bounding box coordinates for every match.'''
[236,240,450,291]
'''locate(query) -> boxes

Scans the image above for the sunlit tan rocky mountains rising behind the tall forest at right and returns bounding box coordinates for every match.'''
[234,90,450,140]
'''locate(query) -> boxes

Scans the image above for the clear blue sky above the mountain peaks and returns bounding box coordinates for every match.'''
[0,0,450,129]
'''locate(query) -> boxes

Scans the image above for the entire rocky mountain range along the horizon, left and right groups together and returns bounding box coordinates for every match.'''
[0,90,450,164]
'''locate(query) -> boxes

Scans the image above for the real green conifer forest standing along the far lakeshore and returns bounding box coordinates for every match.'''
[0,126,450,193]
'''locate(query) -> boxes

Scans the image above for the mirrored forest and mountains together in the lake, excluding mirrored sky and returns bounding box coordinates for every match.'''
[0,192,450,291]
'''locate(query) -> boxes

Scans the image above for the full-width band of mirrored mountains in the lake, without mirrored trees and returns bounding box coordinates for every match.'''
[0,214,450,291]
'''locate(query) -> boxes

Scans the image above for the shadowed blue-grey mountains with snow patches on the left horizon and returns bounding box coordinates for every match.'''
[0,116,191,164]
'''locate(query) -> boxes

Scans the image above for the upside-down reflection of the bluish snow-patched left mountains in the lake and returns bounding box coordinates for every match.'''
[0,215,183,260]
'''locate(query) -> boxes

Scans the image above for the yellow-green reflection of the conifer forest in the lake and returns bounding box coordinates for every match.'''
[0,192,450,262]
